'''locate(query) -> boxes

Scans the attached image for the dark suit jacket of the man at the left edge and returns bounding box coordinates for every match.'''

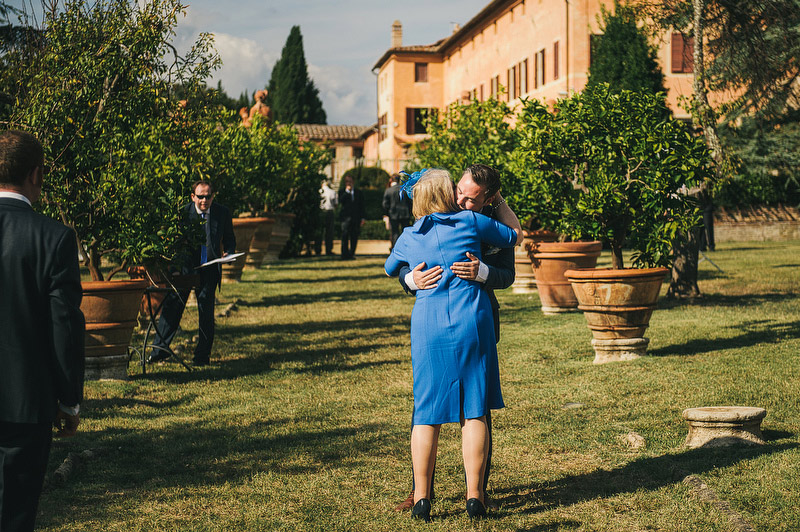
[0,198,85,424]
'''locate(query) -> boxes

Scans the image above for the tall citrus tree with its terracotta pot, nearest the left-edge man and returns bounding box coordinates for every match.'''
[10,0,215,378]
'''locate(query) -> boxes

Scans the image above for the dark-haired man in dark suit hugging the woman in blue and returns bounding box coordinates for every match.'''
[395,164,522,512]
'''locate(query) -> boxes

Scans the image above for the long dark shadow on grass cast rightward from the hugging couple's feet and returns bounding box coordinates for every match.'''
[494,442,798,516]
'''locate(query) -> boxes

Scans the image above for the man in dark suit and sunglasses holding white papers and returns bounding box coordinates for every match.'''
[147,181,236,366]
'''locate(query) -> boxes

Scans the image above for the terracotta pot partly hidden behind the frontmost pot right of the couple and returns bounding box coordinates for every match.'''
[528,241,603,316]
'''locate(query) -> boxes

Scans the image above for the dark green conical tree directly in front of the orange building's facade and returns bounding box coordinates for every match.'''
[587,1,664,93]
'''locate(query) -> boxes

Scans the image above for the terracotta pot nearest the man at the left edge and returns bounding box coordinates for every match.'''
[81,280,150,380]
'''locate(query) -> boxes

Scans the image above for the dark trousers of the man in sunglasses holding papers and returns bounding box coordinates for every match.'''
[154,266,220,363]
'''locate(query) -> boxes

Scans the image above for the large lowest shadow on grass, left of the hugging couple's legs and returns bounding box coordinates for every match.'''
[37,420,396,528]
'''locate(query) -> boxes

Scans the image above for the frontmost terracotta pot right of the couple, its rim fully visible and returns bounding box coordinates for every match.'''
[565,268,669,364]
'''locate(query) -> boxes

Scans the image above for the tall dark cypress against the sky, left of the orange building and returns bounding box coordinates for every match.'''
[267,26,326,124]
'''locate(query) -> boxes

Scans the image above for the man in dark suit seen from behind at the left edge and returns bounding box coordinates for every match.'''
[0,131,85,532]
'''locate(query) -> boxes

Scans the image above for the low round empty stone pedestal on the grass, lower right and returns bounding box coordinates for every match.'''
[683,406,767,449]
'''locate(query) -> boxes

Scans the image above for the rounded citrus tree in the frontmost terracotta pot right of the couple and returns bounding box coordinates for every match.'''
[524,84,711,363]
